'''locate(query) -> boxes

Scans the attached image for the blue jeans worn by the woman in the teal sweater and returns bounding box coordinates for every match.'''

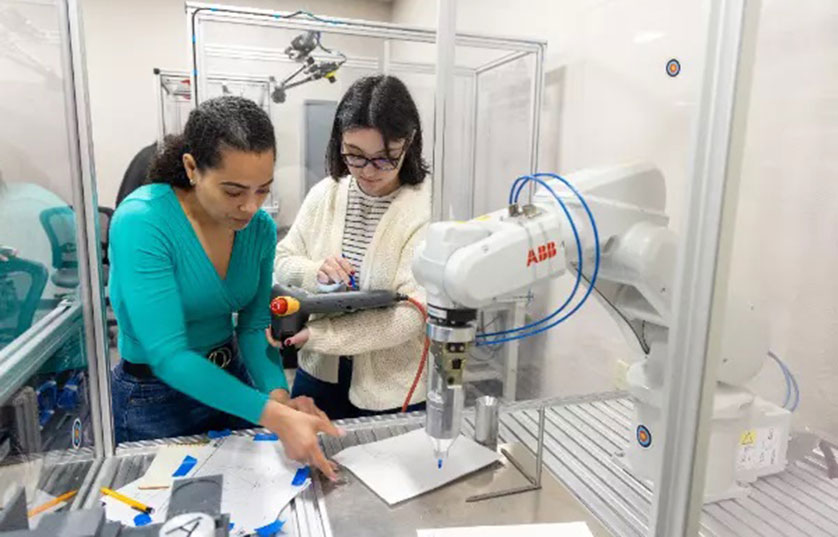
[111,354,253,442]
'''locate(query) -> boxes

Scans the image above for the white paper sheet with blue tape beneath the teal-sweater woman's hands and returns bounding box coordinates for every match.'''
[190,436,311,535]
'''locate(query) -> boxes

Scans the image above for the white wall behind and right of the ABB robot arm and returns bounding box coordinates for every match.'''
[393,0,838,436]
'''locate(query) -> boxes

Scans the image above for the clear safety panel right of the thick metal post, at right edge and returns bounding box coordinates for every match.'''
[703,2,838,536]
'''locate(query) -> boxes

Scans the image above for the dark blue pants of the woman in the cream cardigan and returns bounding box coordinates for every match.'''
[291,357,425,420]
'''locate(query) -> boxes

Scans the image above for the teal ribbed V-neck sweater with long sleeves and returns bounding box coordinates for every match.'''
[110,184,288,423]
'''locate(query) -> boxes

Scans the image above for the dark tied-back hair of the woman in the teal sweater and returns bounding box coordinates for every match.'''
[148,95,276,189]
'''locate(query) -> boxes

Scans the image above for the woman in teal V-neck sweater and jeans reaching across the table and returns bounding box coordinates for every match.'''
[110,97,338,477]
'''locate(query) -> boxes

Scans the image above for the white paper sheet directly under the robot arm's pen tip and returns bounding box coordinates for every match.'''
[335,429,499,505]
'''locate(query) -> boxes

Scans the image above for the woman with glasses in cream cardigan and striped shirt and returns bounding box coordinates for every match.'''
[272,75,431,419]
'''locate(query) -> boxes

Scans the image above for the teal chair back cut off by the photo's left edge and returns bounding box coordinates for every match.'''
[0,257,48,346]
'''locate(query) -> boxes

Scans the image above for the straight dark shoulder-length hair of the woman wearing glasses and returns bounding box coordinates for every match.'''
[326,75,428,185]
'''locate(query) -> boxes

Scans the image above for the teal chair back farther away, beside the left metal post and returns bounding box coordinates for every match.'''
[40,205,79,290]
